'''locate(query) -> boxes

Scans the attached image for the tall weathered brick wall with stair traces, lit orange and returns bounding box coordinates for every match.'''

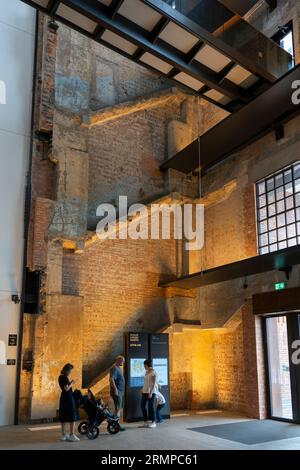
[21,0,300,421]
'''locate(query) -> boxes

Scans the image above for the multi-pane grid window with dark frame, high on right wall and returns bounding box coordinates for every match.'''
[256,161,300,255]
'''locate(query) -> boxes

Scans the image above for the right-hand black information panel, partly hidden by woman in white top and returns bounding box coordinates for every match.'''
[149,333,170,418]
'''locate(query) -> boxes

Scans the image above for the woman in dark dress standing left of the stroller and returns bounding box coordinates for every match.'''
[58,364,80,442]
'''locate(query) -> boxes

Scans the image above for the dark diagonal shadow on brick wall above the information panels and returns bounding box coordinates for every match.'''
[82,297,171,388]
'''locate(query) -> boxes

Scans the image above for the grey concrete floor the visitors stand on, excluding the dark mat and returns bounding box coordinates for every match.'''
[0,411,300,450]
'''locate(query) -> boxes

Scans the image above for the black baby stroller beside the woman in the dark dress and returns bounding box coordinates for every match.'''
[74,390,120,440]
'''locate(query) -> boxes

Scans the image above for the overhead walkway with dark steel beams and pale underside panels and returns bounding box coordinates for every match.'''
[23,0,293,113]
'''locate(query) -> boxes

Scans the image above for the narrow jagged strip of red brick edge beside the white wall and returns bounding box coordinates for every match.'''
[27,14,57,269]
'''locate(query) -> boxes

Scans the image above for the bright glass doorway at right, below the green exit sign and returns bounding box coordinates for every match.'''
[265,313,300,423]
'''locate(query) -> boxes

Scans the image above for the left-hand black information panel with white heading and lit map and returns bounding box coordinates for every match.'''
[124,333,149,421]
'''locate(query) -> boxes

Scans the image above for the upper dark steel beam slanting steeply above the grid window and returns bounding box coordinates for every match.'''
[161,65,300,173]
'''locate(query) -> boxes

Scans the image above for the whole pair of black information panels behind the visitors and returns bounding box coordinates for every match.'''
[124,333,170,421]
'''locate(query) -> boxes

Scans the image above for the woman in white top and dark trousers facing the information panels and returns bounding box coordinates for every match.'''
[141,359,158,428]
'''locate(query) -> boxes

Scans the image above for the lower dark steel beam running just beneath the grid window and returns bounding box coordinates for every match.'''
[160,246,300,289]
